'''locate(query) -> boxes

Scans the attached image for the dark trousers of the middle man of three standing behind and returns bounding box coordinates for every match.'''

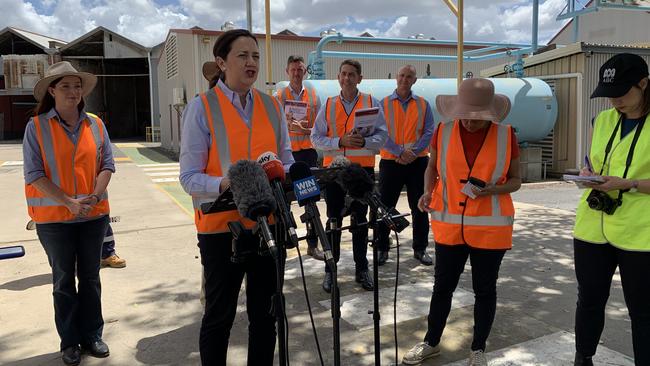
[325,168,375,273]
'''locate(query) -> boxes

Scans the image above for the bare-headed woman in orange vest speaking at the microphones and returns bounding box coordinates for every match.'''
[180,29,293,366]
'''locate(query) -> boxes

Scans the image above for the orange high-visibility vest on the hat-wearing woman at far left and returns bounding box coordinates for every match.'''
[25,114,110,224]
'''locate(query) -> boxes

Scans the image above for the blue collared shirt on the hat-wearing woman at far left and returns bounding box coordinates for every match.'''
[23,108,115,184]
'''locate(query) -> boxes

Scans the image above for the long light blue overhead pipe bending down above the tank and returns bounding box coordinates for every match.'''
[309,33,530,80]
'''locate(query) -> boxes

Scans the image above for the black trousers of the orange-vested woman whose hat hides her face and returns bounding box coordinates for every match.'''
[424,243,506,351]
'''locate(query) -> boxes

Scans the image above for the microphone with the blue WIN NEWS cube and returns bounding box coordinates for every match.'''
[289,161,336,272]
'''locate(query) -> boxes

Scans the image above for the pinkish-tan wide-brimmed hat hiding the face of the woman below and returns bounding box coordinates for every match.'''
[436,78,510,122]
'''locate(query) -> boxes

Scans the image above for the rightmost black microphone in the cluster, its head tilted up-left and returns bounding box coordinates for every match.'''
[337,163,409,233]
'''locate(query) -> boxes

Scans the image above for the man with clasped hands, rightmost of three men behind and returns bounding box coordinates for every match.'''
[377,65,435,266]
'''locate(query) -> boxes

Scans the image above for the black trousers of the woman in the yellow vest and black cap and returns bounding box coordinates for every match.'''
[573,238,650,366]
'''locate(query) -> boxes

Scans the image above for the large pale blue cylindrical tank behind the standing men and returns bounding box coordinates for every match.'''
[277,78,558,142]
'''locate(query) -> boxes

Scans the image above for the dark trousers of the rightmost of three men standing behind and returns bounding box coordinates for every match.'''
[377,156,429,251]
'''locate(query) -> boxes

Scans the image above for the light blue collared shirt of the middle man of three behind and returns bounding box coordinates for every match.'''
[311,91,388,151]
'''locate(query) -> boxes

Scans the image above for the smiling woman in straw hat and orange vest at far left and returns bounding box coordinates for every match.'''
[23,61,115,365]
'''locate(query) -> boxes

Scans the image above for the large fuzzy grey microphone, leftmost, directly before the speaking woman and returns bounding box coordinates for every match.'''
[228,160,278,259]
